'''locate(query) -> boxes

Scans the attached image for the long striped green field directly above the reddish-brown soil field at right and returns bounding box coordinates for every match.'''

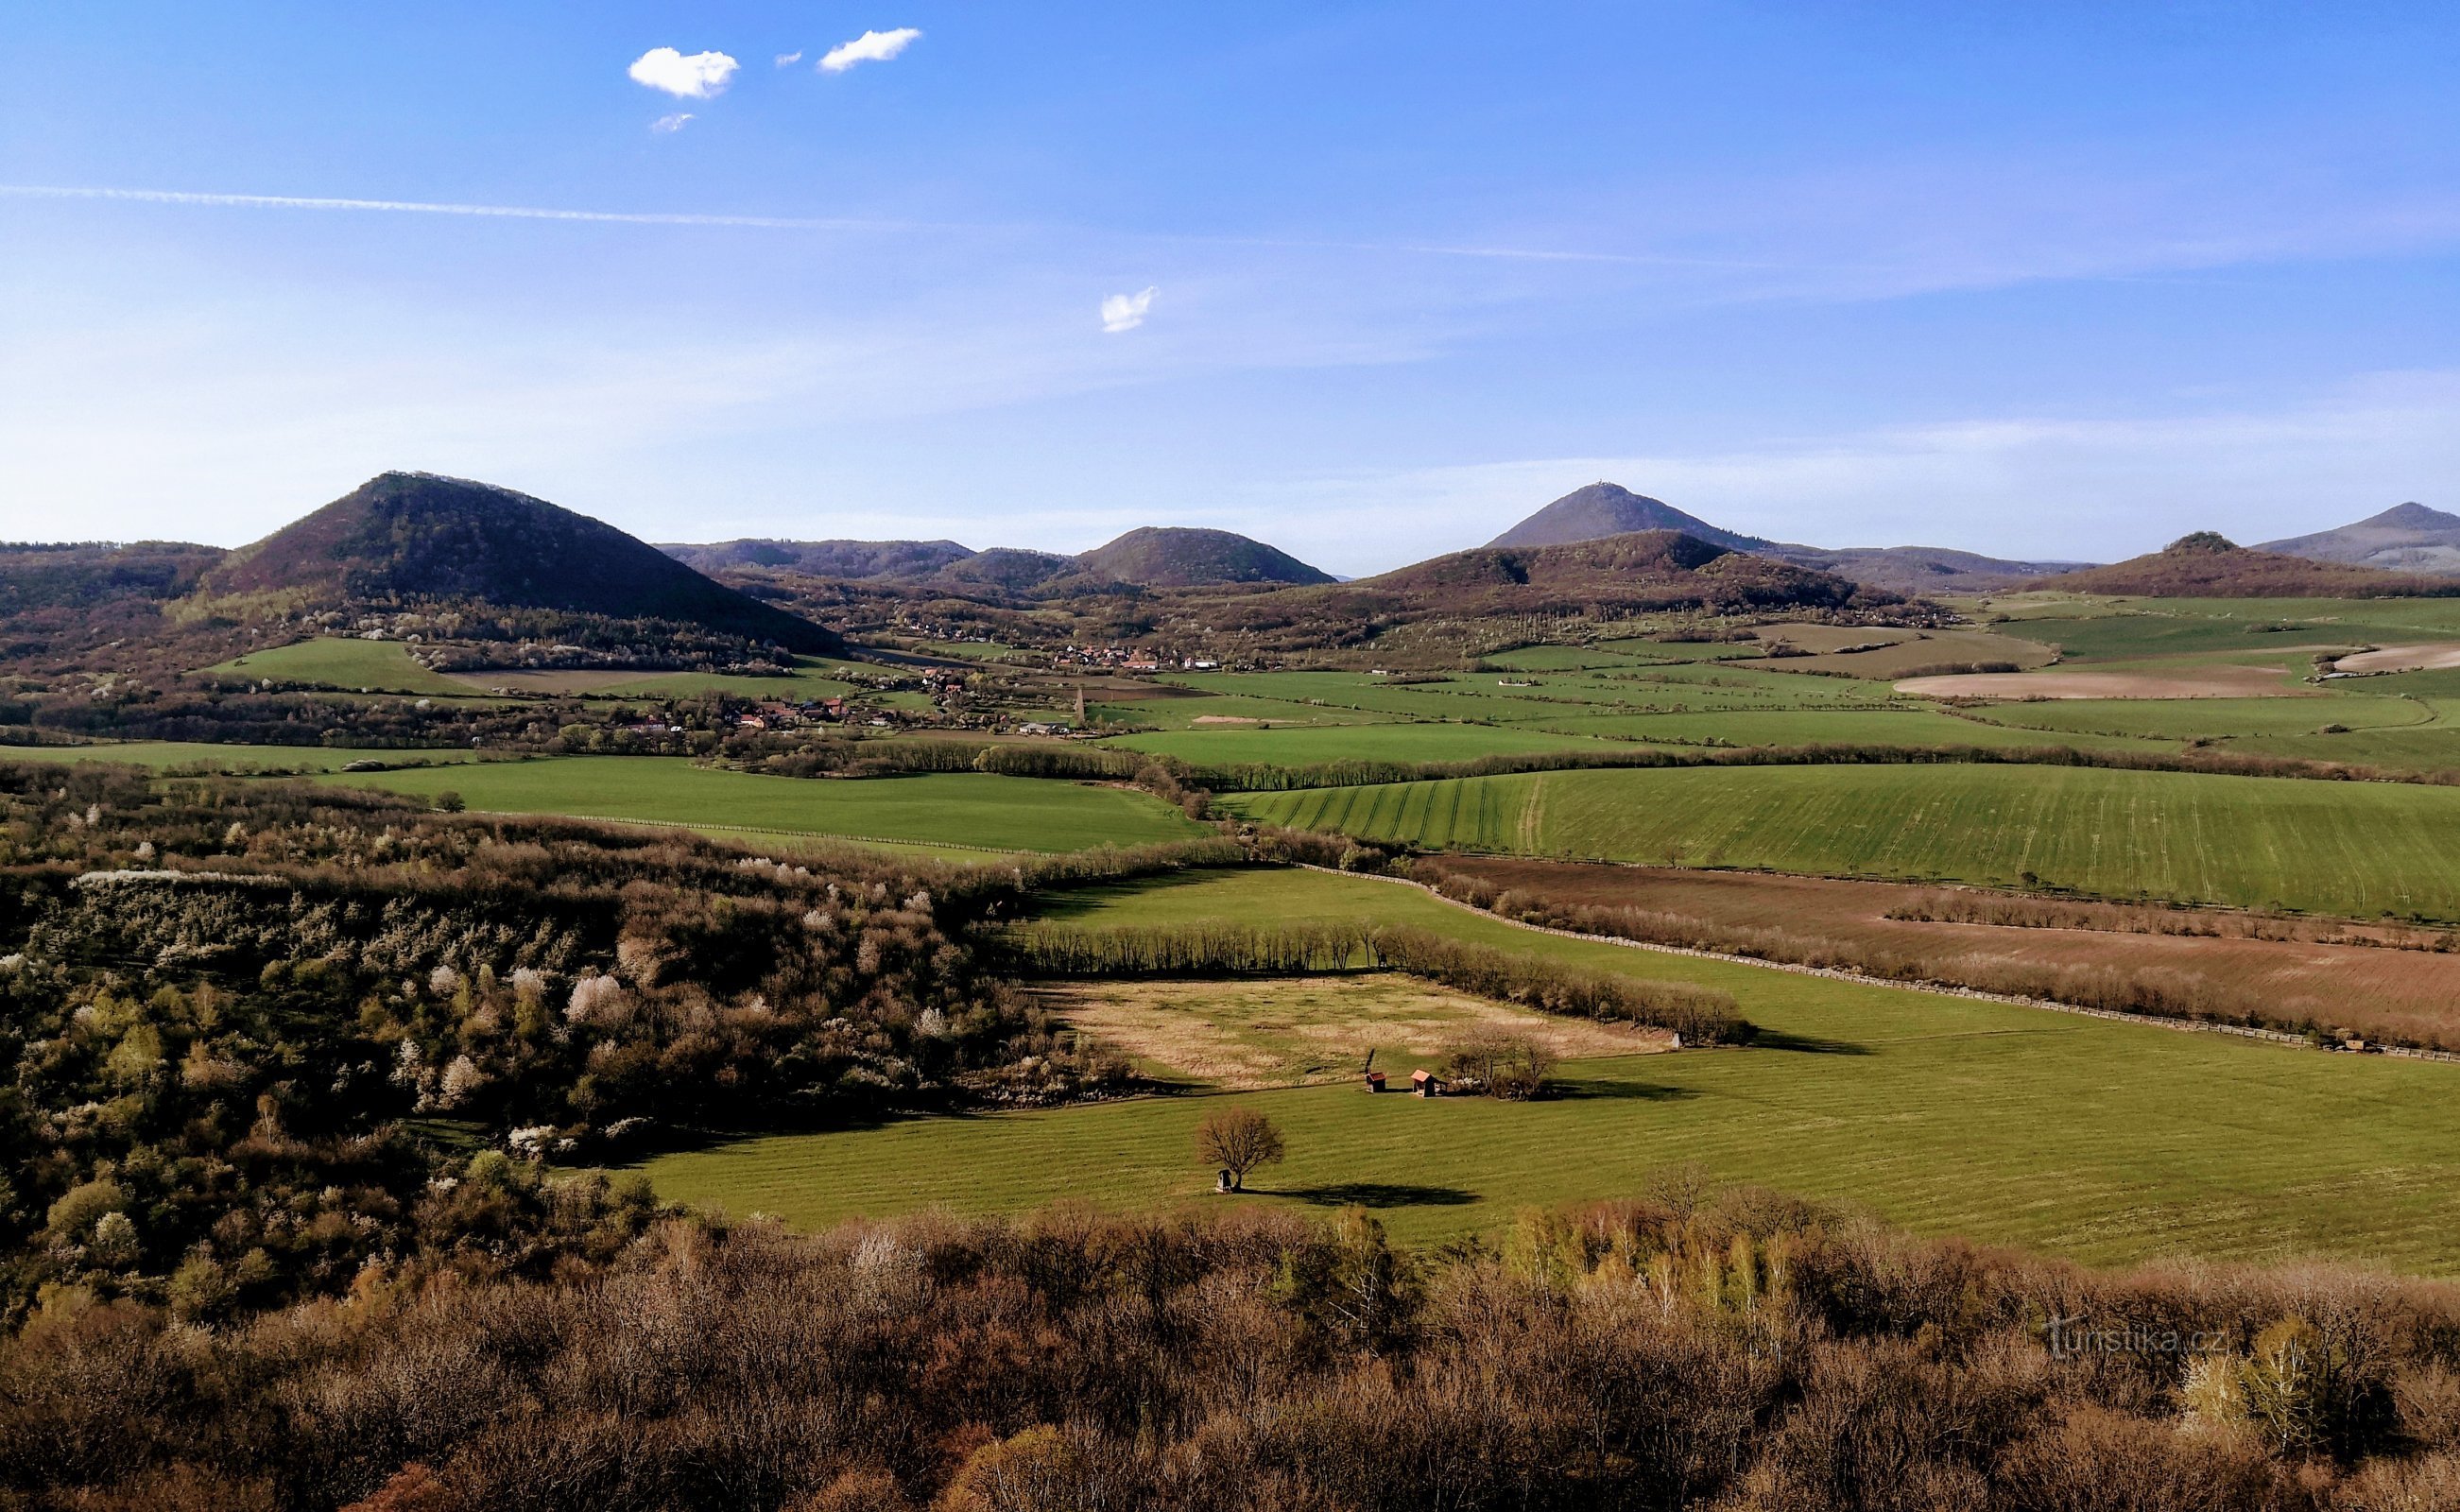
[1223,765,2460,919]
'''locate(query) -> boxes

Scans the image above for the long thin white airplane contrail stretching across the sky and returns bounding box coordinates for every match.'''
[0,184,1774,268]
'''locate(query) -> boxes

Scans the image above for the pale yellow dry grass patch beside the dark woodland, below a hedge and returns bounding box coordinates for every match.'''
[1036,973,1670,1090]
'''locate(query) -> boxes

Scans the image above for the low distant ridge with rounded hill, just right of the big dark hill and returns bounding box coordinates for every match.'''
[660,526,1335,595]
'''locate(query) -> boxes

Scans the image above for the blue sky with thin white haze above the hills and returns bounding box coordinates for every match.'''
[0,0,2460,573]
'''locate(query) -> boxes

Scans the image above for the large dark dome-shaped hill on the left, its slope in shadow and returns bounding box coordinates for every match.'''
[197,472,841,654]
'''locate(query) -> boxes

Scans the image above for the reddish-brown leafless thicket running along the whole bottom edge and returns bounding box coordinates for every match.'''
[0,1199,2460,1512]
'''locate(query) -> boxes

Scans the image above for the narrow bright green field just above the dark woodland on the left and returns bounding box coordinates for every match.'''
[312,757,1205,850]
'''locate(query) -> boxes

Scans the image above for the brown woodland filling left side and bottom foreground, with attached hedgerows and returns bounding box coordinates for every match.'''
[14,767,2460,1512]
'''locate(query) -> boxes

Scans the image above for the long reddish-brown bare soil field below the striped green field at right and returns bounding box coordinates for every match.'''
[1444,855,2460,1045]
